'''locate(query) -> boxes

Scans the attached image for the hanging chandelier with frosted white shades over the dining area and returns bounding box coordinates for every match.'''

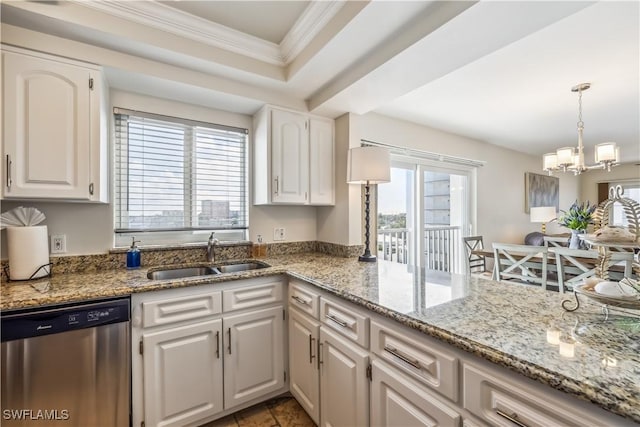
[542,83,620,175]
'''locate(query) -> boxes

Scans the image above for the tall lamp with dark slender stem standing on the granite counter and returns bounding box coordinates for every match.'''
[347,146,391,262]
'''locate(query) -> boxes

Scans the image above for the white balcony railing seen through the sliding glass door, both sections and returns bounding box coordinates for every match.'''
[378,226,464,273]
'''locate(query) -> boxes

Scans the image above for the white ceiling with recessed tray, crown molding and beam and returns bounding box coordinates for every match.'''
[2,0,640,162]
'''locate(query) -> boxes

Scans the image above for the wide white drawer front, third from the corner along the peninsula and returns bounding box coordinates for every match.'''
[371,320,458,402]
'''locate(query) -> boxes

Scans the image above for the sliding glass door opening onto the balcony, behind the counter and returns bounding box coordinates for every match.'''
[377,156,475,273]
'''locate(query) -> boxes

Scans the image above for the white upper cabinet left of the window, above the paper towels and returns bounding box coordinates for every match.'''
[2,46,108,202]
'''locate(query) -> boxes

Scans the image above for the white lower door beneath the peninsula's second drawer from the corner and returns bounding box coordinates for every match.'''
[320,326,369,426]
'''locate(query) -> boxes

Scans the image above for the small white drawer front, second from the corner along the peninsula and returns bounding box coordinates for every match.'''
[320,297,369,348]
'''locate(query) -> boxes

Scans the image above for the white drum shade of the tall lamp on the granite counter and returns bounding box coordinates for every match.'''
[347,146,391,184]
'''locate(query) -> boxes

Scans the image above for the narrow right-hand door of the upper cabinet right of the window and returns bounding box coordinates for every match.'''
[309,119,335,205]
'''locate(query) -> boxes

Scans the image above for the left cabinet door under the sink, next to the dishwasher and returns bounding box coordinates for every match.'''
[142,319,222,426]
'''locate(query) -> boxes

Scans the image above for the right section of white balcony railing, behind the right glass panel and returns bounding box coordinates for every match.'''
[424,225,464,273]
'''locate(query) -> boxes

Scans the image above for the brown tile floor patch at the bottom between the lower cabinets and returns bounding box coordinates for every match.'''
[201,395,315,427]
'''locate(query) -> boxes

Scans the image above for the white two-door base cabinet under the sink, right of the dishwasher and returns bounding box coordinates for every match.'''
[131,276,286,427]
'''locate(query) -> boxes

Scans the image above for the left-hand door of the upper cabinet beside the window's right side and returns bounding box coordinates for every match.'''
[271,110,309,204]
